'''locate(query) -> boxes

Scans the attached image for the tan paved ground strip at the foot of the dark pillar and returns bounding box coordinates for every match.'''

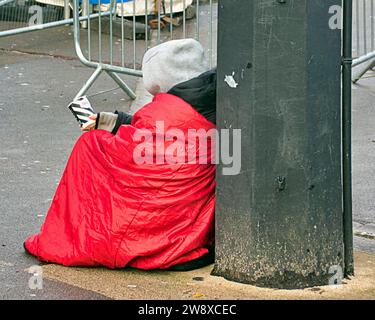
[43,252,375,300]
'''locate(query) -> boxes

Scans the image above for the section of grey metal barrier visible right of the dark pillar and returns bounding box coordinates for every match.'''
[353,0,375,83]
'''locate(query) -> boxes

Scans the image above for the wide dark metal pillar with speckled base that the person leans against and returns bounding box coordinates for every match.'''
[213,0,352,288]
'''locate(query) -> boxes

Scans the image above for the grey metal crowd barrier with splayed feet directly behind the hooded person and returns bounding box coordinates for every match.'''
[73,0,217,99]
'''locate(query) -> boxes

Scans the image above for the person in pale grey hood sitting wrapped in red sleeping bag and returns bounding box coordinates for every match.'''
[24,39,216,270]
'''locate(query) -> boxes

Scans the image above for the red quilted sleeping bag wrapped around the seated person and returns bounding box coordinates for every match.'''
[25,93,215,269]
